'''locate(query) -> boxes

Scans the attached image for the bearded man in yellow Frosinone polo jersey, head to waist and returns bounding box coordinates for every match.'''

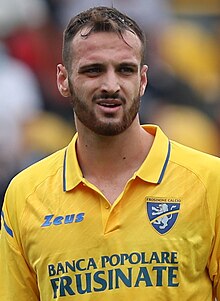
[0,7,220,301]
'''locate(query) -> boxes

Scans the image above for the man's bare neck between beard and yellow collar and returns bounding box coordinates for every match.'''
[77,119,153,179]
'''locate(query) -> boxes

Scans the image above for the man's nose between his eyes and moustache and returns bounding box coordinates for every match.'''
[101,70,120,94]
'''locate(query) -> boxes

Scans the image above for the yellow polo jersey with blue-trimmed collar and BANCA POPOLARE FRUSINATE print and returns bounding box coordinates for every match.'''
[0,125,220,301]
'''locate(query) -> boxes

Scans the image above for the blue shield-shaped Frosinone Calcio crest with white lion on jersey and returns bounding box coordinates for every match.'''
[146,197,181,234]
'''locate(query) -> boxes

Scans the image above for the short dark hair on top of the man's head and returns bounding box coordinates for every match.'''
[62,6,146,69]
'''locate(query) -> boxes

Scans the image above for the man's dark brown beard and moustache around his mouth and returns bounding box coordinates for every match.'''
[69,82,140,136]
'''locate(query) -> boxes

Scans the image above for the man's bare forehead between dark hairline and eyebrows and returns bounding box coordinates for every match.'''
[71,29,142,63]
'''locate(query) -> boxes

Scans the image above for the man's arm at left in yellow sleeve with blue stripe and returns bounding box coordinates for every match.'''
[0,188,40,301]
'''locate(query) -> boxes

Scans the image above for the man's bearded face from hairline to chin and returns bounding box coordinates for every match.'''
[58,31,147,136]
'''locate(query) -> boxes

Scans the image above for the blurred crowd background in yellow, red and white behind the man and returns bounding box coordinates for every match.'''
[0,0,220,210]
